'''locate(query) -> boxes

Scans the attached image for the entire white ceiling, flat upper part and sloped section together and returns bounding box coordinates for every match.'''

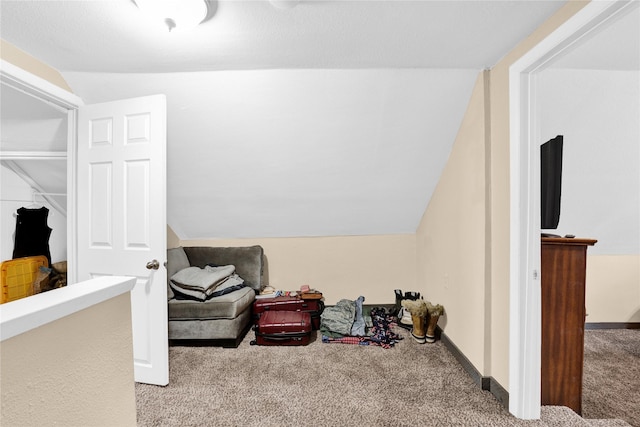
[0,0,564,239]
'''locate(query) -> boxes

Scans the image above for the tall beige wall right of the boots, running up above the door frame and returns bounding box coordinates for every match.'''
[417,1,588,390]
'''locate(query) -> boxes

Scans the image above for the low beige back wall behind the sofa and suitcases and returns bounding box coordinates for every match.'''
[180,234,416,304]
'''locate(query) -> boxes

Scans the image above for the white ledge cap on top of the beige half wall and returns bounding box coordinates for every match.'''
[0,276,136,341]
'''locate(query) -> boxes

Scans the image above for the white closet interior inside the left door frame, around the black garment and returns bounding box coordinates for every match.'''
[0,77,68,263]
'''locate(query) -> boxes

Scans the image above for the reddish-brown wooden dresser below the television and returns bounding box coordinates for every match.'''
[541,237,597,415]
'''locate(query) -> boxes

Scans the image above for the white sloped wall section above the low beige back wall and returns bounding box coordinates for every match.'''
[64,69,477,240]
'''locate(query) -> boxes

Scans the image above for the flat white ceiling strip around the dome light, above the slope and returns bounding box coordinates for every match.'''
[2,0,564,73]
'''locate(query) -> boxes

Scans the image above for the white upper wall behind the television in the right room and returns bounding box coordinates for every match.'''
[539,69,640,255]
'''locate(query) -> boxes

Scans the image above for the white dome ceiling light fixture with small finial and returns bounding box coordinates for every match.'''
[133,0,211,32]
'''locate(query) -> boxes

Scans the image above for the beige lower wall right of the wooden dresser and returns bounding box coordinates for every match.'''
[586,255,640,323]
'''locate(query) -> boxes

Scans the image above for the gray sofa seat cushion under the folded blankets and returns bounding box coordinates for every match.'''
[169,287,256,320]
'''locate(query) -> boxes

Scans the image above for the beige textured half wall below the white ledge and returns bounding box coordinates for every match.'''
[0,292,136,427]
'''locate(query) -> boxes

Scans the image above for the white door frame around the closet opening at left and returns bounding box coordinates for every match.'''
[0,59,84,283]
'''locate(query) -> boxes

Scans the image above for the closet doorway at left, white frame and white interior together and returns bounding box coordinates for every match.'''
[0,60,83,283]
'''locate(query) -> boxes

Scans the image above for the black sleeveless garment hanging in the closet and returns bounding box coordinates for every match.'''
[13,206,52,265]
